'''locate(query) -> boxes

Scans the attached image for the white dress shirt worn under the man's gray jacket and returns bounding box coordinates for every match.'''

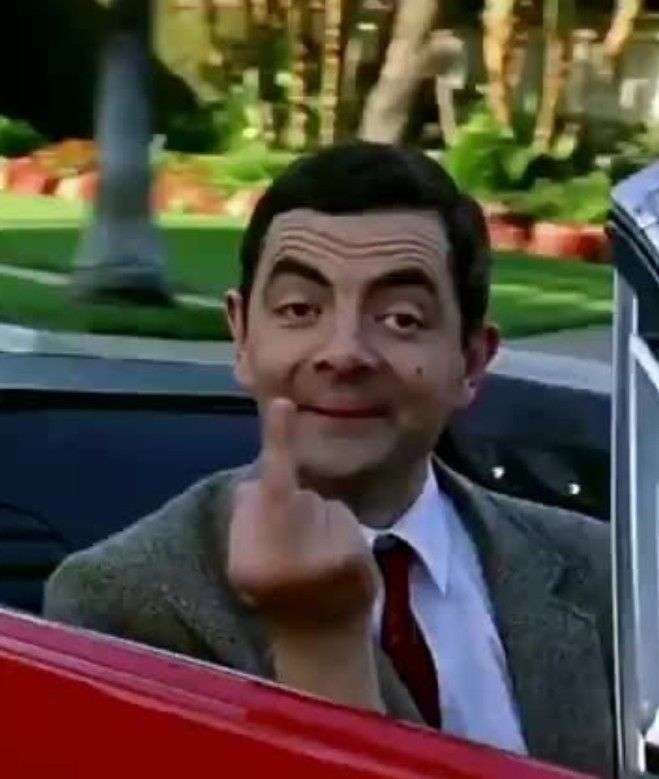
[364,466,527,754]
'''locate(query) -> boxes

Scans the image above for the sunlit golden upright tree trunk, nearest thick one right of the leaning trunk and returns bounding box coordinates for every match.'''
[483,0,517,127]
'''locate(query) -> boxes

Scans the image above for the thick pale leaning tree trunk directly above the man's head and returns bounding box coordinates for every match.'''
[359,0,440,143]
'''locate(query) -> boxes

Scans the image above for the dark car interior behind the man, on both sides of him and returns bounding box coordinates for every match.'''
[0,357,610,613]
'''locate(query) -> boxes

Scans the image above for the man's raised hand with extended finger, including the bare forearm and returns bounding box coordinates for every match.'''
[228,399,384,711]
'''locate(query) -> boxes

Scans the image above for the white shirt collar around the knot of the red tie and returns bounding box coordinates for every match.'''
[363,463,452,595]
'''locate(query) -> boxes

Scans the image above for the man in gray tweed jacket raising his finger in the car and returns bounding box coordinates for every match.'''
[45,143,613,774]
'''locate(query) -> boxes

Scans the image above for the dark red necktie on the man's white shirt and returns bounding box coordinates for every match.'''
[375,536,441,728]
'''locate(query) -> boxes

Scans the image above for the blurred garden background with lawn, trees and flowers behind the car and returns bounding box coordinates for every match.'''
[0,0,659,348]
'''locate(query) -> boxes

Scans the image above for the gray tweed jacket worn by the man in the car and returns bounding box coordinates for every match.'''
[44,462,614,775]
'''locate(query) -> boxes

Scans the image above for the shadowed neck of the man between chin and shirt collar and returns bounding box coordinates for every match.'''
[300,460,428,530]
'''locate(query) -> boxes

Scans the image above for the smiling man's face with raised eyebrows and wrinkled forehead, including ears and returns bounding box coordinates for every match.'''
[228,209,494,479]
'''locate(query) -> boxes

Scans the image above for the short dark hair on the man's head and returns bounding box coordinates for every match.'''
[240,141,492,340]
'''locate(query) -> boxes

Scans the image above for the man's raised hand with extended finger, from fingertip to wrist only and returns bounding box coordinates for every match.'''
[229,398,378,633]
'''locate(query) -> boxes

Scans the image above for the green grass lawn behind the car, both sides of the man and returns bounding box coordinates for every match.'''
[0,194,613,339]
